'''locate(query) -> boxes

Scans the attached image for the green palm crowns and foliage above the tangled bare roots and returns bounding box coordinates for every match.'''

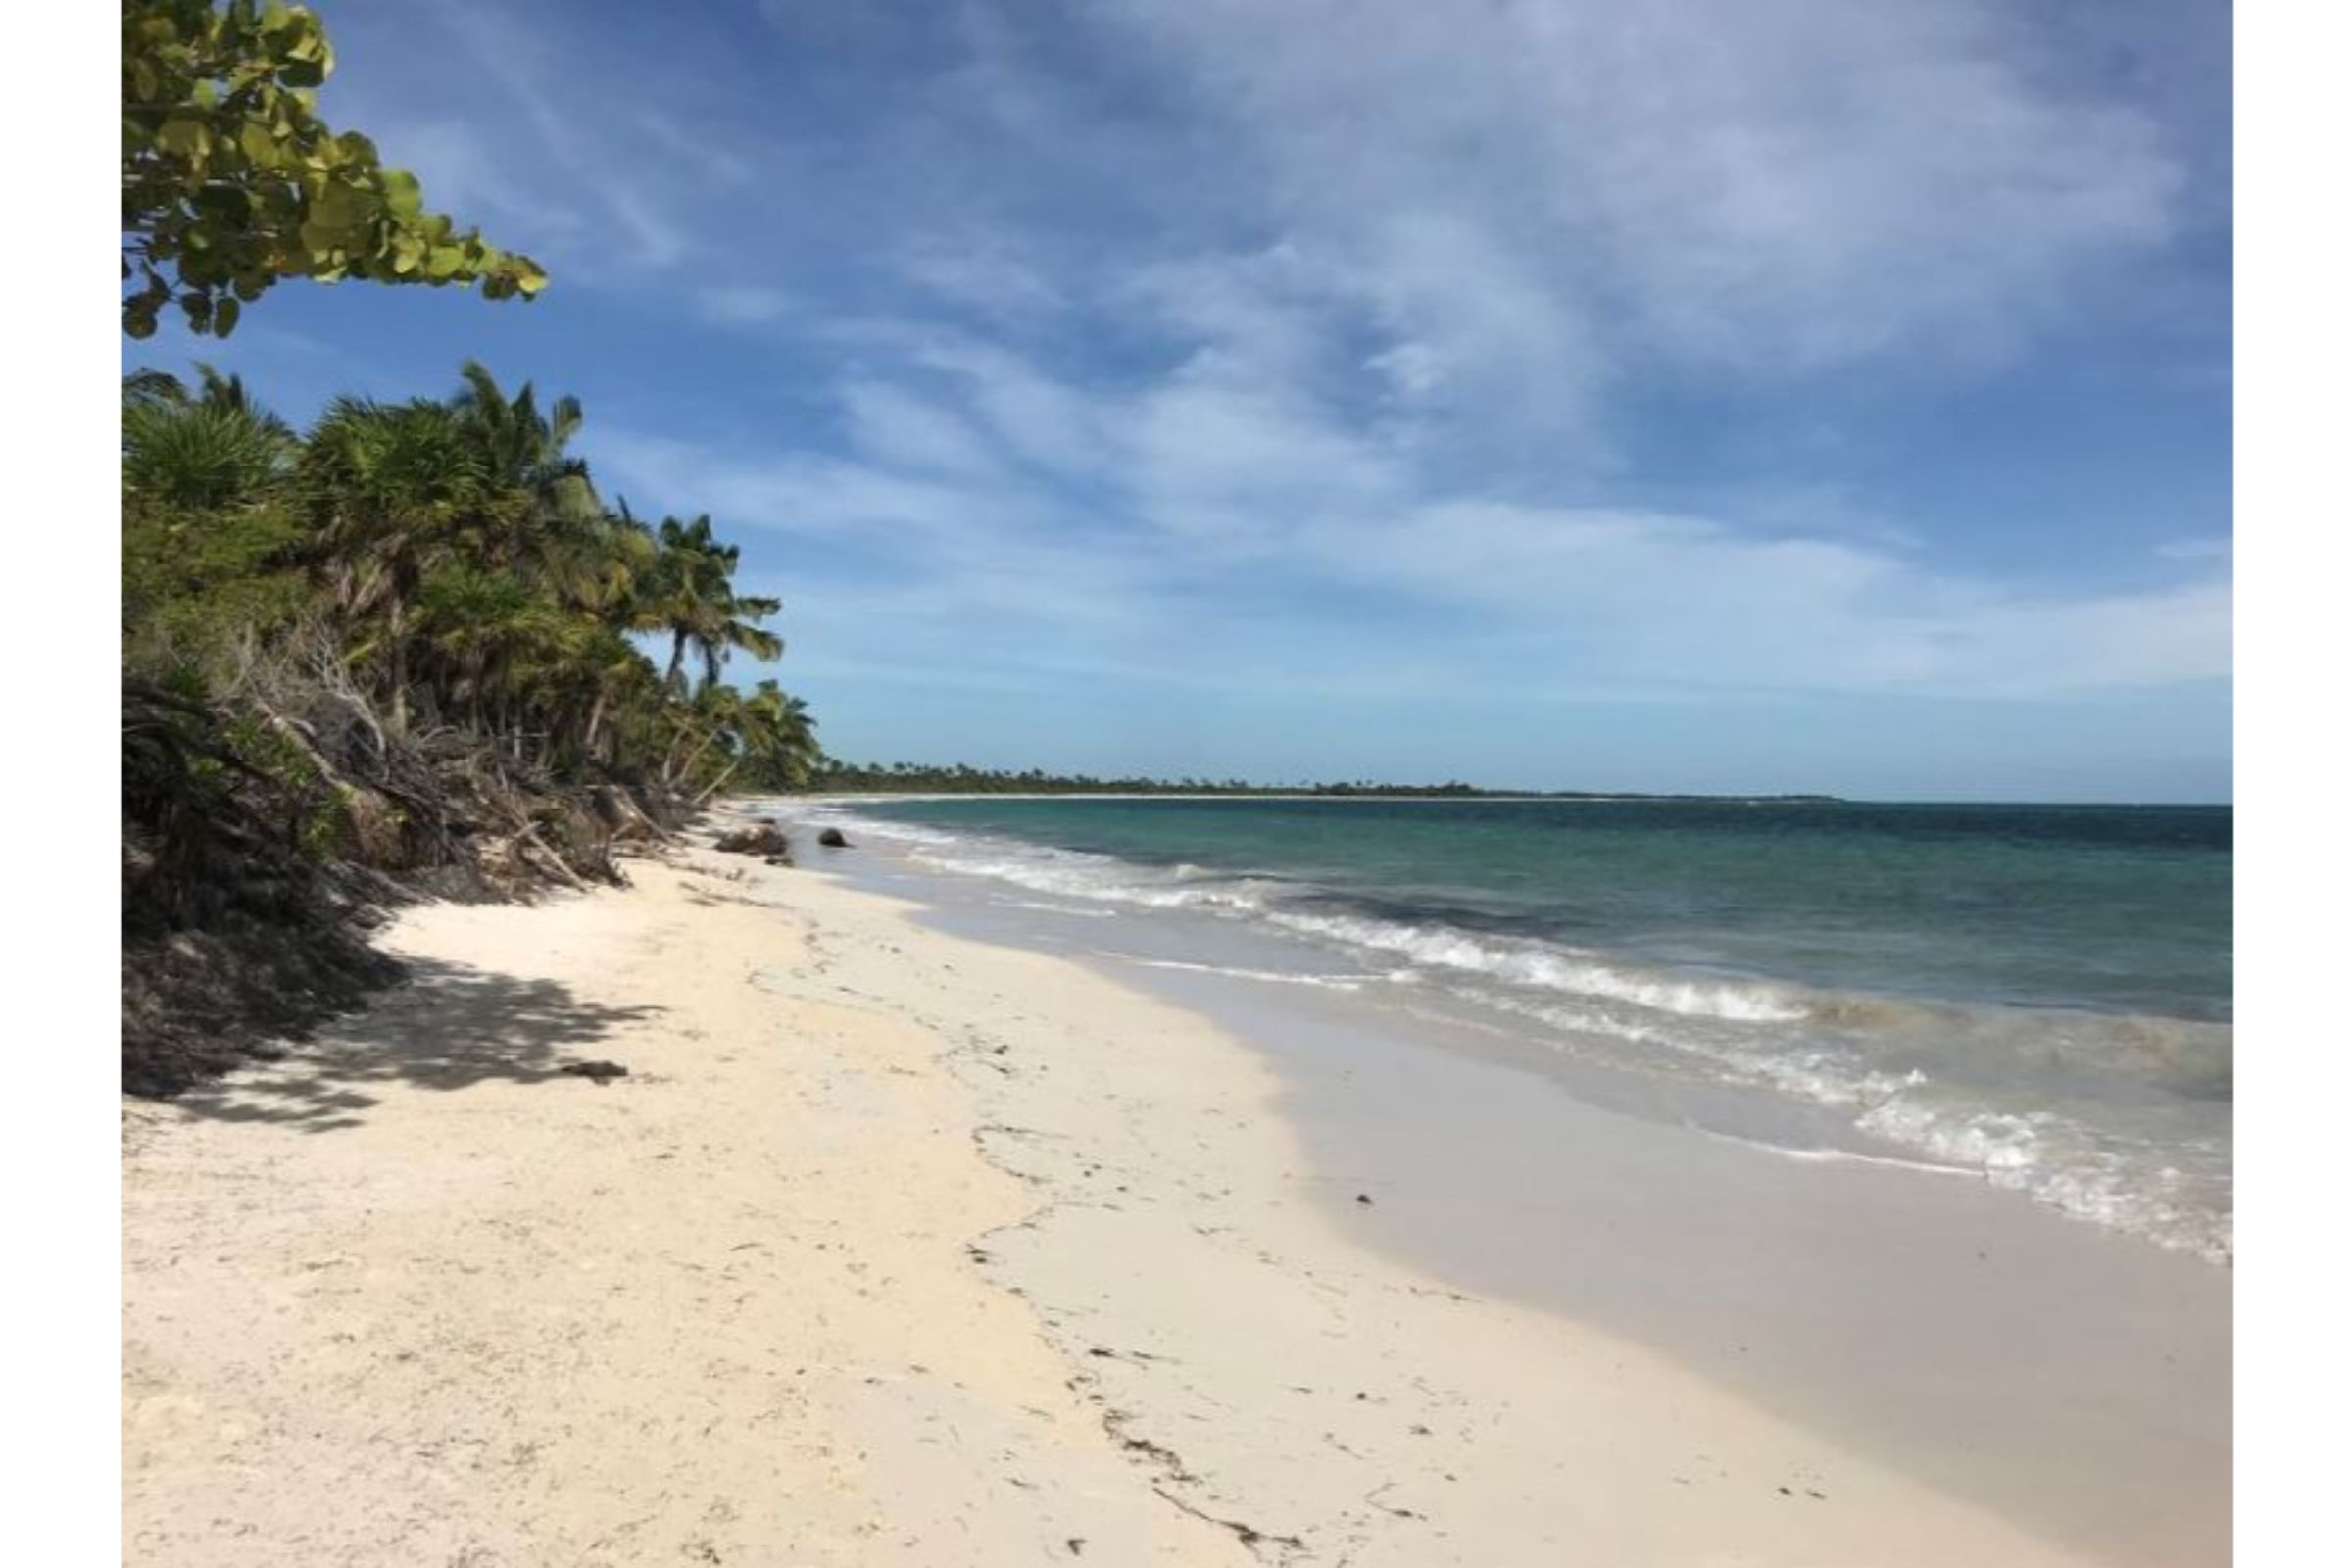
[122,365,816,795]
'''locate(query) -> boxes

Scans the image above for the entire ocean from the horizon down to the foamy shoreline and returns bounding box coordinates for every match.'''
[785,797,2232,1262]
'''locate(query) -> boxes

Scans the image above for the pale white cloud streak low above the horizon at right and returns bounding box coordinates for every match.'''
[1312,503,2230,696]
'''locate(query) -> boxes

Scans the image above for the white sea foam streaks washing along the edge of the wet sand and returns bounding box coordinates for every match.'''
[766,807,2232,1262]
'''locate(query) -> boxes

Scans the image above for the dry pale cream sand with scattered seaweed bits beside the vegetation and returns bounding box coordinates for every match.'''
[122,827,2117,1568]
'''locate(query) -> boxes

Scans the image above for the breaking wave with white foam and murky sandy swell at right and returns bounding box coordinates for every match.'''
[780,807,2232,1262]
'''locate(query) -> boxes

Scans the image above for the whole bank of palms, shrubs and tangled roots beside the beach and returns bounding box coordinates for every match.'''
[122,365,818,1081]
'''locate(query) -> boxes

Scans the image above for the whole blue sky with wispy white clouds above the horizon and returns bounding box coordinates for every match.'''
[127,0,2232,802]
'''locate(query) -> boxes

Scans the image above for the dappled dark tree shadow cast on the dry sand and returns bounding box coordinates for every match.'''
[172,959,661,1133]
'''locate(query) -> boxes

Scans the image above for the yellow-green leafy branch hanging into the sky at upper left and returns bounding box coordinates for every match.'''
[122,0,548,338]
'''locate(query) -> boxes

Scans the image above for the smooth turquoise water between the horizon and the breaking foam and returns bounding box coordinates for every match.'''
[842,800,2230,1020]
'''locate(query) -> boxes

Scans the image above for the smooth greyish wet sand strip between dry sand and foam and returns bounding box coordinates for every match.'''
[825,817,2232,1568]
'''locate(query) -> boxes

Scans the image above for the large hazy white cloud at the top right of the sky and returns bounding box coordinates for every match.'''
[1115,0,2180,411]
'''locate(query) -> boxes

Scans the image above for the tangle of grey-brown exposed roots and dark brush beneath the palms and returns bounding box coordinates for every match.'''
[122,651,684,1096]
